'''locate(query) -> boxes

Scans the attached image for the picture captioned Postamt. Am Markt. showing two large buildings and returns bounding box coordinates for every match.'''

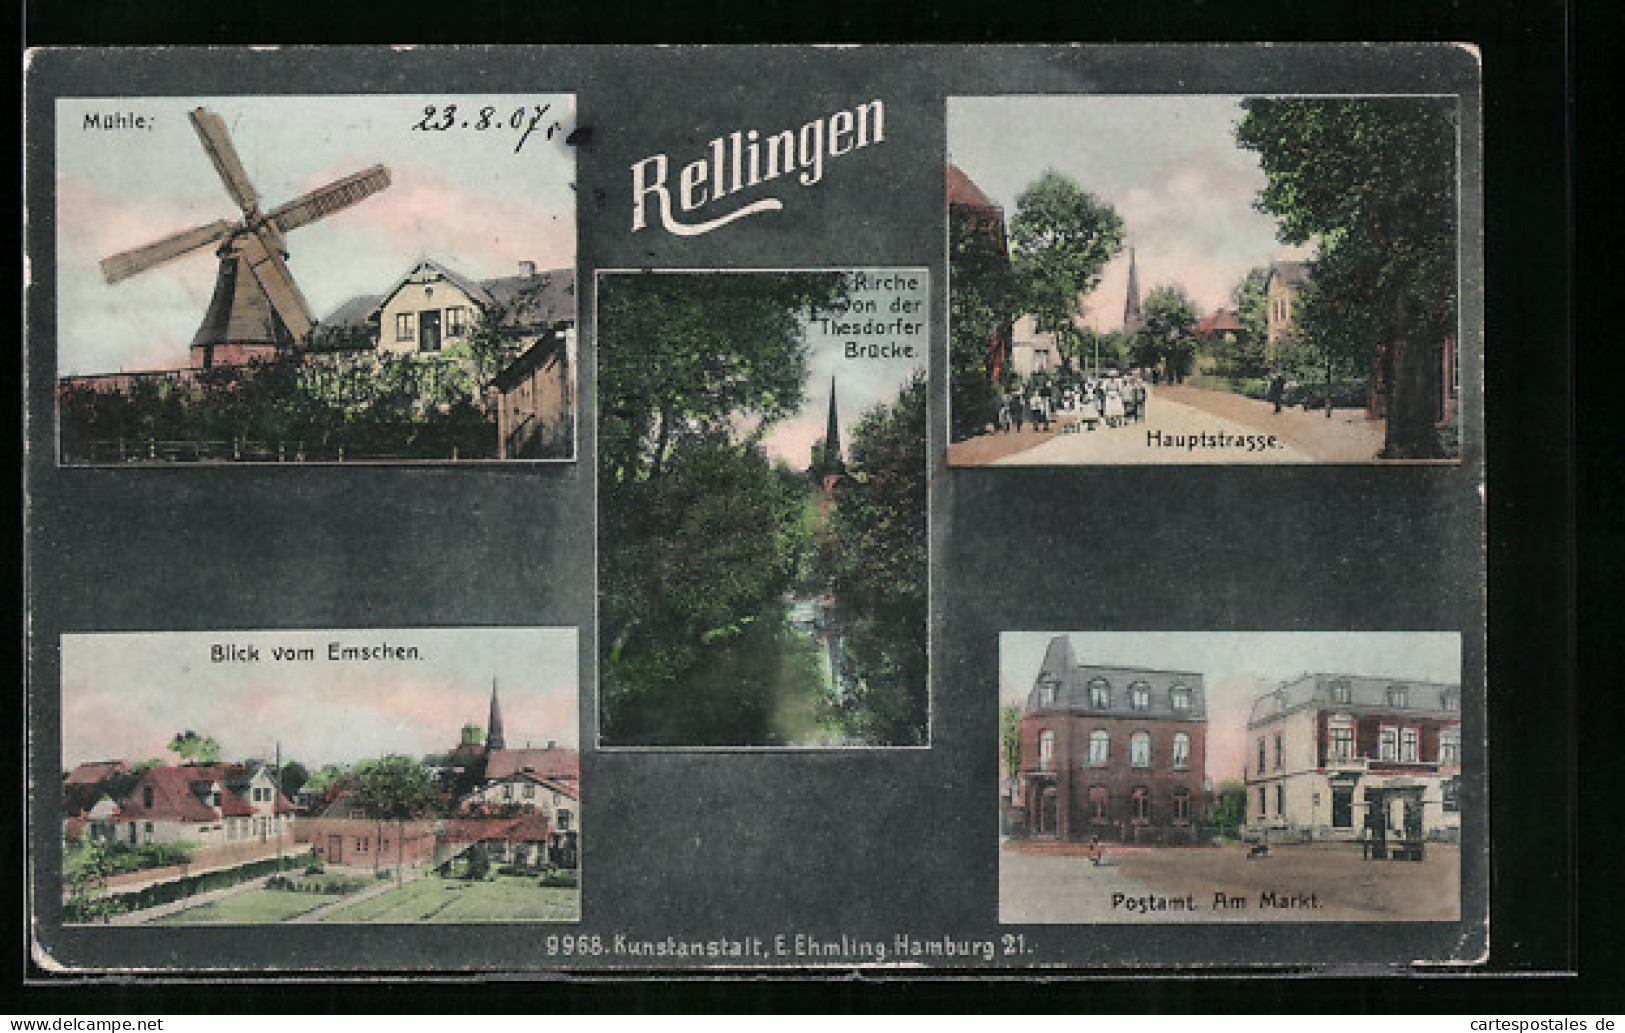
[999,632,1482,924]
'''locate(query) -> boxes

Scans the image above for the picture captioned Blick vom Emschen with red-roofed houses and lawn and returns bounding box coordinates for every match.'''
[52,629,582,927]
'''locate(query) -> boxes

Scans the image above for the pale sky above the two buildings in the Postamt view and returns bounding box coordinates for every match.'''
[999,632,1461,786]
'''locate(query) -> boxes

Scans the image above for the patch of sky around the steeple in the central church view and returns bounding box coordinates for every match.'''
[762,270,931,469]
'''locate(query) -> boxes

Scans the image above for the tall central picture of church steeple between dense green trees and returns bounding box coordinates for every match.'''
[596,270,930,747]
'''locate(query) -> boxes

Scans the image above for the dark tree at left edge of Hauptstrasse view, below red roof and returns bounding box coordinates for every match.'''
[947,210,1022,442]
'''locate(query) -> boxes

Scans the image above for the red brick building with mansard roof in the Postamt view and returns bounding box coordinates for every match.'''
[1012,635,1209,843]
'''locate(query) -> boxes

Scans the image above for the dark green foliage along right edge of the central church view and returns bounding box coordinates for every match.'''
[830,374,928,746]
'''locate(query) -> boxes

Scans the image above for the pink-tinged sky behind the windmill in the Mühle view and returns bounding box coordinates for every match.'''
[57,94,575,375]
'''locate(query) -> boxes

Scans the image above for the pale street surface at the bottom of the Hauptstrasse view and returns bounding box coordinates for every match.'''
[995,388,1315,466]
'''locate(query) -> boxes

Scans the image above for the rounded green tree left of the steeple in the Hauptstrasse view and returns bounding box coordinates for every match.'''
[1011,169,1123,335]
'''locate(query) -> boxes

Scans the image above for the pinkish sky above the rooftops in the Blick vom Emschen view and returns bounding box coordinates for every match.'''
[62,629,579,768]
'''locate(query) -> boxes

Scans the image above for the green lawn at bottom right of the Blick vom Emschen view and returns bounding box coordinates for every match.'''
[310,875,580,923]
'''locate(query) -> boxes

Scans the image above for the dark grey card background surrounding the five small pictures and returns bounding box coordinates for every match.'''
[26,47,1489,971]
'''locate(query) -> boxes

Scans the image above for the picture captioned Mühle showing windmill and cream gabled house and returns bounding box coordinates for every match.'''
[55,94,577,466]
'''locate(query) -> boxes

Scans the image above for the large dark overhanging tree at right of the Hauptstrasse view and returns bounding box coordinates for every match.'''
[1235,99,1456,458]
